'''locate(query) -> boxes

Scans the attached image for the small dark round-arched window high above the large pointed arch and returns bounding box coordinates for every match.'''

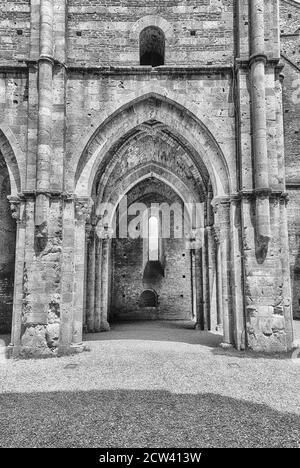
[140,26,165,67]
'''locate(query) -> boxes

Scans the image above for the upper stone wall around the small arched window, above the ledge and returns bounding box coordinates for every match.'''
[68,0,233,66]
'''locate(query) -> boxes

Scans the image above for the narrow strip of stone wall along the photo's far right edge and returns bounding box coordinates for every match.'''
[280,0,300,318]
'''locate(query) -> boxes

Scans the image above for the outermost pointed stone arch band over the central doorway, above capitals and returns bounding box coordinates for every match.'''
[70,93,232,196]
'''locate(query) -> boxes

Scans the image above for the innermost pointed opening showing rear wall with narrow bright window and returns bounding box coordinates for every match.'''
[110,177,193,322]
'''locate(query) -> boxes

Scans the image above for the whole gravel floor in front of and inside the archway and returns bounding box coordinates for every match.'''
[0,322,300,447]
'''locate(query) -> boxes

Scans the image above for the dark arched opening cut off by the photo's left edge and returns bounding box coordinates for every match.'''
[0,151,16,334]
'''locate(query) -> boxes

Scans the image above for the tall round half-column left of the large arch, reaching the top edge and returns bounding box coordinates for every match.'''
[35,0,54,231]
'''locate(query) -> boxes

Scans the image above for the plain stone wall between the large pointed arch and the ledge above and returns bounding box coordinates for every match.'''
[65,71,236,194]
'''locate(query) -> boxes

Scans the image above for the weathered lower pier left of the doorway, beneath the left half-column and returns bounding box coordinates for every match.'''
[21,198,62,357]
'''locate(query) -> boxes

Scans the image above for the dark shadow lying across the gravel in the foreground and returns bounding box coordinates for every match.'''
[0,390,300,448]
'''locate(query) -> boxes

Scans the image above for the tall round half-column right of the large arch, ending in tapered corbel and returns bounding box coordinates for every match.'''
[250,0,271,247]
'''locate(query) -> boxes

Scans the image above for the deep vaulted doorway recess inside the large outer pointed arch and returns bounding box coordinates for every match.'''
[85,122,221,331]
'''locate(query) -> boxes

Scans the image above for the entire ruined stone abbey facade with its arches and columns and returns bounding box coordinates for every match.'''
[0,0,300,357]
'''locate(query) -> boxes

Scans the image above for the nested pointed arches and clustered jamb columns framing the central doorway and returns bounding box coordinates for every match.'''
[73,95,237,343]
